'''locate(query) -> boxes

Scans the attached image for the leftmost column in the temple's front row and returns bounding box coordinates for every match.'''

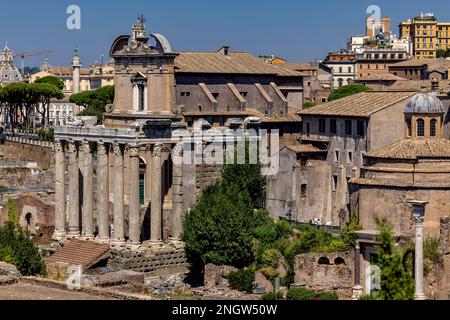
[53,141,67,241]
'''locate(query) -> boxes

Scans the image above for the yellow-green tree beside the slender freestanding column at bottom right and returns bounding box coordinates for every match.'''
[376,218,414,300]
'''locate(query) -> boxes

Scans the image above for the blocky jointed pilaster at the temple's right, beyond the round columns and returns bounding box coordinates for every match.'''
[170,144,183,241]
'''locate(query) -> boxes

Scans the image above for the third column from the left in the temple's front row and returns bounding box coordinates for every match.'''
[82,141,94,240]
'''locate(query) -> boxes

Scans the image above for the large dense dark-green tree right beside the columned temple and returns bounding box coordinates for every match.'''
[183,150,270,274]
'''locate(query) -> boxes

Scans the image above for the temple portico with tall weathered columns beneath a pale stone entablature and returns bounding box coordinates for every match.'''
[54,127,183,247]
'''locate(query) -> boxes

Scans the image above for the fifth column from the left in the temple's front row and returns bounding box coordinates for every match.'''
[113,143,125,245]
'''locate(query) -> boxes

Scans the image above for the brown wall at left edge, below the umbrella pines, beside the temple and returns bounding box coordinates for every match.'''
[0,141,53,170]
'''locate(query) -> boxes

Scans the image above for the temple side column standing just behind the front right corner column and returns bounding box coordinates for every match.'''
[150,144,163,243]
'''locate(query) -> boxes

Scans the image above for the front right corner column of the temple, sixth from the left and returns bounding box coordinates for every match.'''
[128,146,141,245]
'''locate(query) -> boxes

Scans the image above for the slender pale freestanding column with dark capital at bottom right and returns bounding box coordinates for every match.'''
[407,200,428,300]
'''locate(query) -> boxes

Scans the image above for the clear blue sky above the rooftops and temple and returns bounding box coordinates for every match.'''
[0,0,450,66]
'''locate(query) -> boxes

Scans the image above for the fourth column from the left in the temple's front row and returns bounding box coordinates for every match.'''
[97,142,110,243]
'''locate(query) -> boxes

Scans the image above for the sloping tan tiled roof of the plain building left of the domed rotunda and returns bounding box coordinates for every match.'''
[300,91,415,117]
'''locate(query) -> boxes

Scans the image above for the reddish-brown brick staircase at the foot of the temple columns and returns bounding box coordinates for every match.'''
[44,240,110,276]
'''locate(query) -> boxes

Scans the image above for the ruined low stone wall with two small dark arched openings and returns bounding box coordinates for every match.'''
[294,252,355,299]
